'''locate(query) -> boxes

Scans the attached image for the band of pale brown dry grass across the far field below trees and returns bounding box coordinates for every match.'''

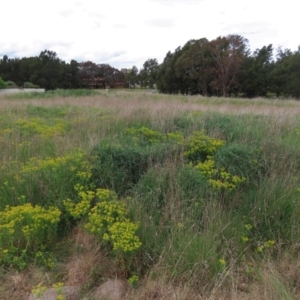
[0,91,300,117]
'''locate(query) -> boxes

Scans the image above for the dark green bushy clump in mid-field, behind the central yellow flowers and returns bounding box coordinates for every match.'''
[92,139,180,196]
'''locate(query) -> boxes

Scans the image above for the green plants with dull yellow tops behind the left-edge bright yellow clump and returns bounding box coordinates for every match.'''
[0,149,91,209]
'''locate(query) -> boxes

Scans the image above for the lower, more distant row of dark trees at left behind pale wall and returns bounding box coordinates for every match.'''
[0,50,125,90]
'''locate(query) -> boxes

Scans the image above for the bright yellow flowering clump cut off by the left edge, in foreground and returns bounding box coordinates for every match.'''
[0,203,61,269]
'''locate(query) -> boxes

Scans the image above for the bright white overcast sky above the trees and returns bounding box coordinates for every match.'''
[0,0,300,69]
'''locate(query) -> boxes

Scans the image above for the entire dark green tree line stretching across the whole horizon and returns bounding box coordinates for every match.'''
[0,35,300,98]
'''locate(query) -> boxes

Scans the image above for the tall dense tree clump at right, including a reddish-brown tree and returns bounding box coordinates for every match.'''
[155,35,300,98]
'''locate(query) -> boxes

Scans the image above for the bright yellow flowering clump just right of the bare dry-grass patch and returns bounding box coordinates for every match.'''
[63,185,141,256]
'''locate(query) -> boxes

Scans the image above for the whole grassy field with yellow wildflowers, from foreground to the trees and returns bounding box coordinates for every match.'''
[0,90,300,300]
